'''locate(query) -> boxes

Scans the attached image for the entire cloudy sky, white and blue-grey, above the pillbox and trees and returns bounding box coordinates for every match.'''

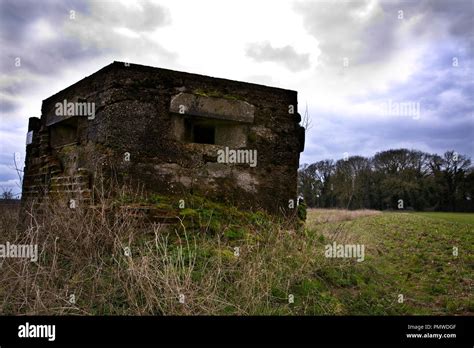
[0,0,474,196]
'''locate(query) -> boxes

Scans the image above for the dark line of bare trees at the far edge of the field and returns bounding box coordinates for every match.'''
[298,149,474,212]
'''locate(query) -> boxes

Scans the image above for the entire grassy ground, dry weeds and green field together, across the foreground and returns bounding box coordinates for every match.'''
[0,203,474,315]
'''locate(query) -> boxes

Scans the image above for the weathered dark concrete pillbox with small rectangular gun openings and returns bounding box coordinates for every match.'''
[24,63,304,212]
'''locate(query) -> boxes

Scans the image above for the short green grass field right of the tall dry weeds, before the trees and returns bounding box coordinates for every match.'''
[302,211,474,315]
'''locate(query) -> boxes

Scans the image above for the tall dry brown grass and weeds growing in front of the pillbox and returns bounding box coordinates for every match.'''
[0,188,321,315]
